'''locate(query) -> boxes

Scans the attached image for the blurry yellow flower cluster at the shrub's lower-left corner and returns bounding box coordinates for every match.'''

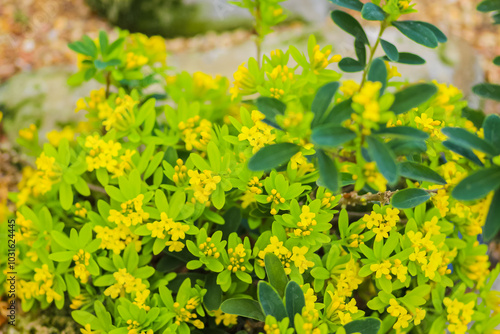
[19,264,62,303]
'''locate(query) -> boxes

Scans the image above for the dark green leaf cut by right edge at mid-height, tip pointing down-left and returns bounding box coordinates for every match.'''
[451,166,500,201]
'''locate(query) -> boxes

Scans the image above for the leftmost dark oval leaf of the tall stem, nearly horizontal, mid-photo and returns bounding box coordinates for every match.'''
[248,143,300,171]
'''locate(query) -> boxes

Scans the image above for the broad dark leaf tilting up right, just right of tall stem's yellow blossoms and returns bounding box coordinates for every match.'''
[390,84,437,115]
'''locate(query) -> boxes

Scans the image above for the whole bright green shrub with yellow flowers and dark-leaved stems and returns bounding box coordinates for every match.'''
[1,0,500,334]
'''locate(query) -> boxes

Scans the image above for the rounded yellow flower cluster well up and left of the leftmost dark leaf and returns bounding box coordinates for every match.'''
[178,115,212,151]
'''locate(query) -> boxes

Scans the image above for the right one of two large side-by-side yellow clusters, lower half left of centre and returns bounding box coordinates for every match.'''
[146,212,189,252]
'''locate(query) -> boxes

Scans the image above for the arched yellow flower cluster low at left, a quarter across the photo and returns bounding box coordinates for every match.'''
[104,268,150,311]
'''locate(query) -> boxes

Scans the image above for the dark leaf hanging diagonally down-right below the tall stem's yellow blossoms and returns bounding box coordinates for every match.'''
[366,136,398,184]
